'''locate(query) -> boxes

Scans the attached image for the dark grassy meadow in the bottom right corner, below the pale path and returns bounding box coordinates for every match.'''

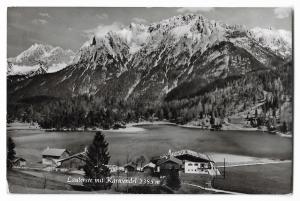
[213,163,293,194]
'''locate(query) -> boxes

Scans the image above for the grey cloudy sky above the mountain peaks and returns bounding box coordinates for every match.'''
[7,7,292,57]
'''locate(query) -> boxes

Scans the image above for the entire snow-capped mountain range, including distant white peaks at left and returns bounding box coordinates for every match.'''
[8,14,292,117]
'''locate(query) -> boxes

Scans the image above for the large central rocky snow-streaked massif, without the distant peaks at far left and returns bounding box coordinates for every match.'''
[11,15,290,105]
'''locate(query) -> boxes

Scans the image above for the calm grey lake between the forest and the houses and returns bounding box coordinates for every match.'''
[7,125,293,164]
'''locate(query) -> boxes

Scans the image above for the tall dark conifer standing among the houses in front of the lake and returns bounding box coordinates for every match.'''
[83,132,111,190]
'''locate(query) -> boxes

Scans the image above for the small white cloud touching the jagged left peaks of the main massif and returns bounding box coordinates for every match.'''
[84,22,123,38]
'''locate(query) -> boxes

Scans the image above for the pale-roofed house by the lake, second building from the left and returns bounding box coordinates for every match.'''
[42,147,70,167]
